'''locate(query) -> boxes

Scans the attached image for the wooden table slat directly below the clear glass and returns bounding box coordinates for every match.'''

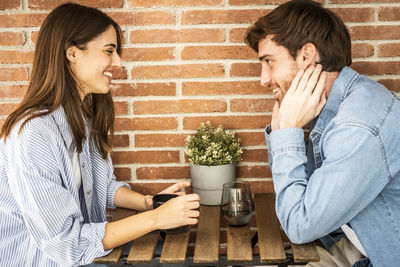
[226,225,253,262]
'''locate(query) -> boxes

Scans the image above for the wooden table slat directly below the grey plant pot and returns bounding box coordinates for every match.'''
[193,205,220,263]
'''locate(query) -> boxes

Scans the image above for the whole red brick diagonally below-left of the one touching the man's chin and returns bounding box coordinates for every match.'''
[133,100,227,114]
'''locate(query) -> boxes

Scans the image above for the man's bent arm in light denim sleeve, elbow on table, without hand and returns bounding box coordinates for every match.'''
[270,124,390,243]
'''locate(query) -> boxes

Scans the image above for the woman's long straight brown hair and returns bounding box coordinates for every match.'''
[0,4,121,159]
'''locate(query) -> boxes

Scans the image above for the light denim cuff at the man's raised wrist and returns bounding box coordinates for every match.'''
[266,127,306,155]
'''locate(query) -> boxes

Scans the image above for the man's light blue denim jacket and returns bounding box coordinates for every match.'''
[266,67,400,266]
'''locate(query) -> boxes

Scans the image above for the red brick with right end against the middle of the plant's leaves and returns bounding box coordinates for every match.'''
[135,134,186,147]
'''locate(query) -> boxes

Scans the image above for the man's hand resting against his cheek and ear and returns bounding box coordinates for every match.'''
[278,64,326,129]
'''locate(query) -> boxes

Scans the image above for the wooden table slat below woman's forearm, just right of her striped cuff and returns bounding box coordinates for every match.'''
[126,231,160,263]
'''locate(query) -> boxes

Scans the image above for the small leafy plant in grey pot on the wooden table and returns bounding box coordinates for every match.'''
[185,121,243,205]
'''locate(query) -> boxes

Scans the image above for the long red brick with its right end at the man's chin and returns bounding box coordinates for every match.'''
[182,81,272,96]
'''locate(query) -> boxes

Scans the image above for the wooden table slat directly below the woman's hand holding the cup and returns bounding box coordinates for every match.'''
[160,226,190,263]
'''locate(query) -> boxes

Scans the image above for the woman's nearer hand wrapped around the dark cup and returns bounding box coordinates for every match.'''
[154,191,200,229]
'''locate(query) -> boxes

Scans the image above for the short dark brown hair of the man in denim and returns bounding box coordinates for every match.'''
[245,0,351,71]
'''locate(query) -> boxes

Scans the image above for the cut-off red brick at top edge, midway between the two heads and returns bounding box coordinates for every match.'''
[128,0,222,7]
